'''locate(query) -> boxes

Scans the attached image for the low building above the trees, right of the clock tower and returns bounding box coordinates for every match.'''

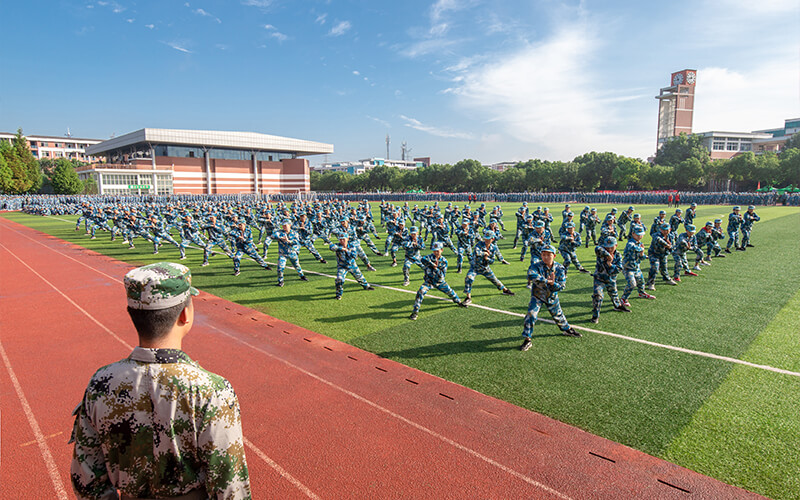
[696,118,800,160]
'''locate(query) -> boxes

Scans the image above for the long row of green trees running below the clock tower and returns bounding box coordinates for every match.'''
[311,134,800,193]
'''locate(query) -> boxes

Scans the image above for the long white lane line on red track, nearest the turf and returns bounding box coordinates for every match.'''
[206,325,570,499]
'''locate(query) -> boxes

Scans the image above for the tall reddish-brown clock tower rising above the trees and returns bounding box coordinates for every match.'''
[656,69,697,149]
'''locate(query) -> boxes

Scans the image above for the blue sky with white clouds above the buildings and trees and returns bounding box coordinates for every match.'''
[0,0,800,164]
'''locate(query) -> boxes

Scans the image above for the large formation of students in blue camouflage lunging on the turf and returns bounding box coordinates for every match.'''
[25,198,760,351]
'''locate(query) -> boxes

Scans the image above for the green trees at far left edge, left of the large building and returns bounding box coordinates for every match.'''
[0,129,97,194]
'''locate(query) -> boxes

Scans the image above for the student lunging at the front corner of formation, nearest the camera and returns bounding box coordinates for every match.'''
[519,246,581,351]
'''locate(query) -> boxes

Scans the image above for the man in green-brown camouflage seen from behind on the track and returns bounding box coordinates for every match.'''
[70,262,251,500]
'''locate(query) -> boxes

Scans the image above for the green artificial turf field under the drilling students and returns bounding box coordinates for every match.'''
[5,204,800,498]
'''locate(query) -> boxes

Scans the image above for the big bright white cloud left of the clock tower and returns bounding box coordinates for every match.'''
[446,22,654,159]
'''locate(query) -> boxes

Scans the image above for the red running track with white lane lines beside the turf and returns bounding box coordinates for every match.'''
[0,219,757,499]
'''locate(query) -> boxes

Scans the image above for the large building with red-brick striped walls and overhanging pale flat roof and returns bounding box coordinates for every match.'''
[78,128,333,194]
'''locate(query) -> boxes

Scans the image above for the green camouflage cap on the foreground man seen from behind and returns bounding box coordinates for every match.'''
[124,262,200,310]
